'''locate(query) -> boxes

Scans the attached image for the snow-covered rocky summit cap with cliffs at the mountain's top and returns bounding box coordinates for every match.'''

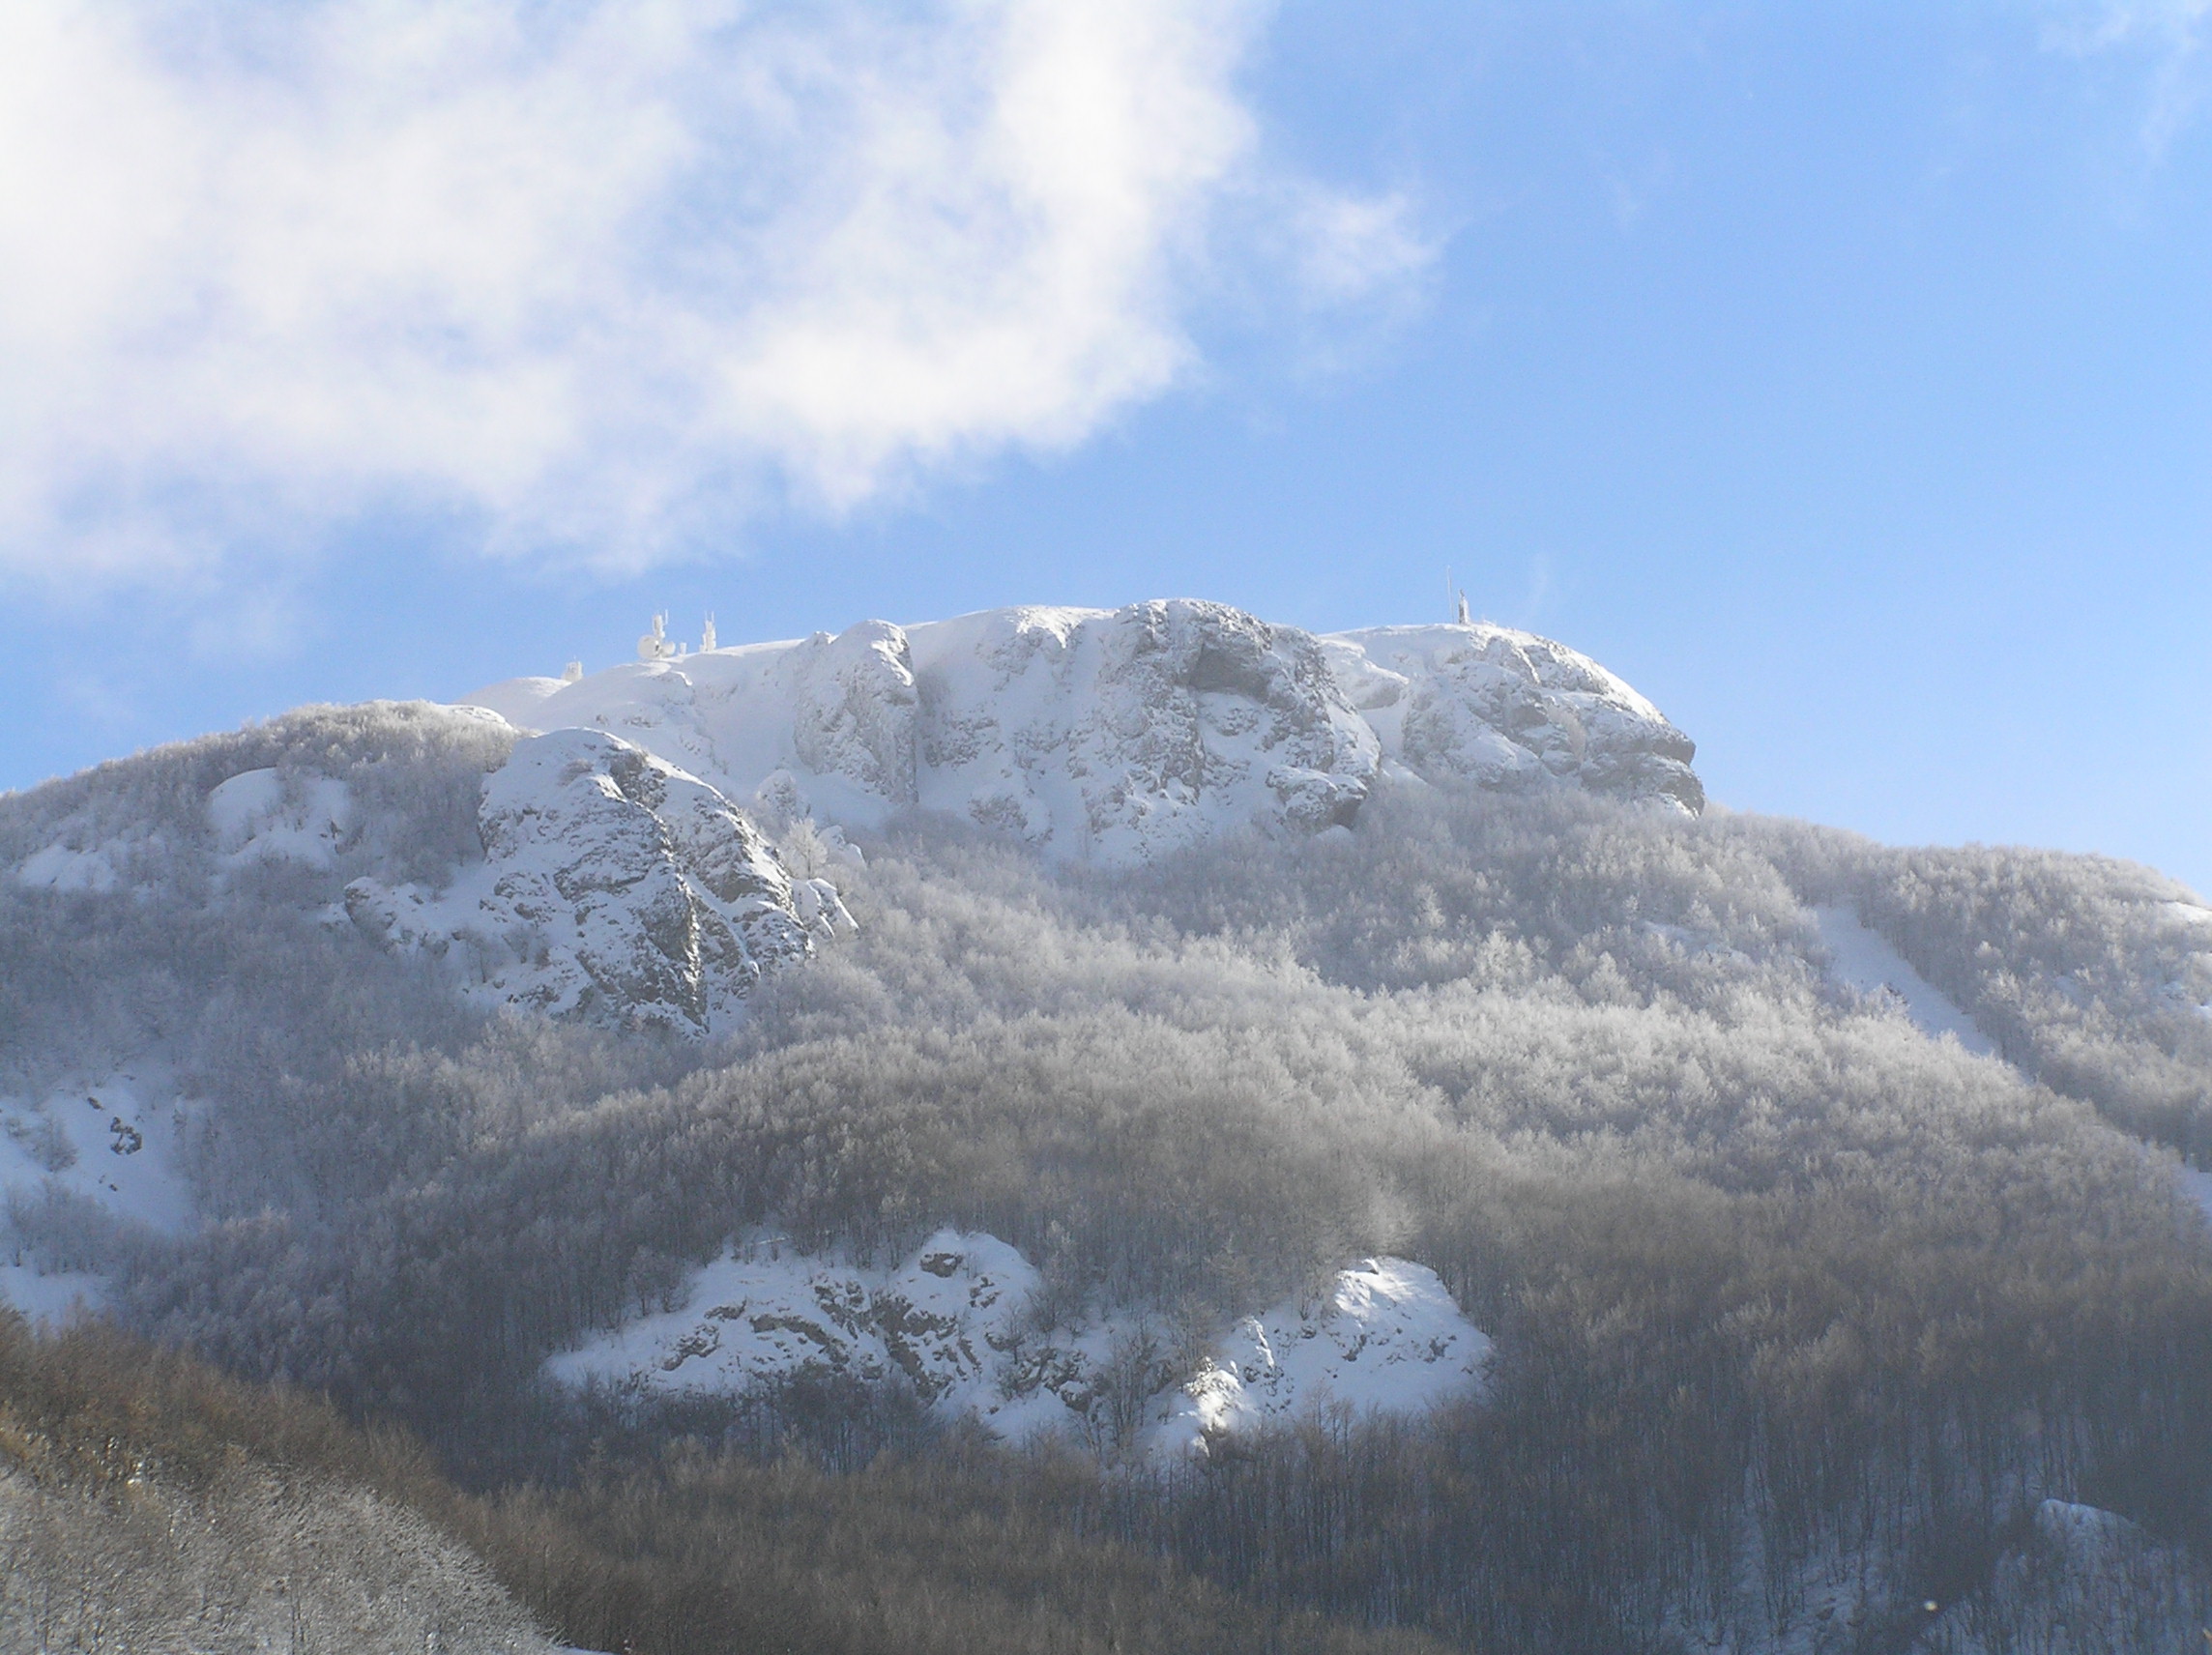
[467,599,1703,865]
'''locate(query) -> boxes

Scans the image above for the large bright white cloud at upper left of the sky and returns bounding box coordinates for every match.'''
[0,0,1424,580]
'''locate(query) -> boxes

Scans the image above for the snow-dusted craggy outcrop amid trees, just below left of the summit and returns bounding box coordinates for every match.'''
[345,730,852,1033]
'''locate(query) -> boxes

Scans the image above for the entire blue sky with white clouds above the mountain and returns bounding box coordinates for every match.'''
[0,0,2212,889]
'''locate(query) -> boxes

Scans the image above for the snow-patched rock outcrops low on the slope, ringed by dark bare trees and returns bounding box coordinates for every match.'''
[546,1228,1491,1454]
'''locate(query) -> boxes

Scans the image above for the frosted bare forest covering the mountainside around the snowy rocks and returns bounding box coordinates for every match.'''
[0,681,2212,1655]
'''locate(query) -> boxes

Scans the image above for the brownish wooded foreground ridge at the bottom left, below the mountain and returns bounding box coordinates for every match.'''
[0,1310,1438,1655]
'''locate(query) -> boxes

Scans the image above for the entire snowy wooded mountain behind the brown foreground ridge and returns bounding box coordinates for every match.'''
[0,602,2212,1655]
